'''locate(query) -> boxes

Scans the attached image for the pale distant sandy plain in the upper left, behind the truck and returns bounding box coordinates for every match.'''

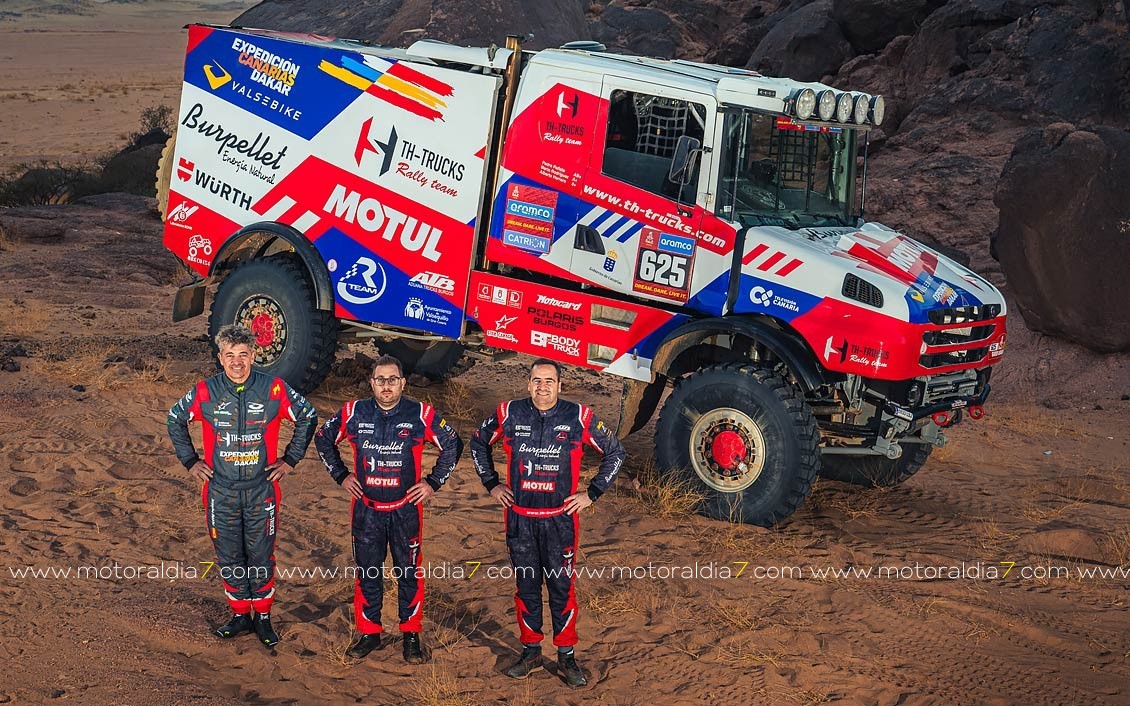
[0,0,254,169]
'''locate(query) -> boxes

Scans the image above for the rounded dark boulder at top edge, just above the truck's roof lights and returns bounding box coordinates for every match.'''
[746,0,853,81]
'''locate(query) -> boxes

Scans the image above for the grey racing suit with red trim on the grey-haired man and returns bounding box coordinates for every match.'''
[166,371,318,615]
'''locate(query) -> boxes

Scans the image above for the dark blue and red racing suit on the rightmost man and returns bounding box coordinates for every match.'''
[471,398,624,647]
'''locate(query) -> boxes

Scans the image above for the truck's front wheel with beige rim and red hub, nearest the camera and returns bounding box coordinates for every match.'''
[655,363,820,526]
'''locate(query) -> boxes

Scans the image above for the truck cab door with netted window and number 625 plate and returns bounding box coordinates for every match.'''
[571,76,716,304]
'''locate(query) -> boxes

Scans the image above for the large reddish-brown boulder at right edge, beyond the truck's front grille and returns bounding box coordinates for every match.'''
[994,123,1130,352]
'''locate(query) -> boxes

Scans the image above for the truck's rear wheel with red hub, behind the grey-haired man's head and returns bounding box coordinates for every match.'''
[208,256,338,393]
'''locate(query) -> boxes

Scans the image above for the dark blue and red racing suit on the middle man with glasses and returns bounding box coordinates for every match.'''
[314,398,463,635]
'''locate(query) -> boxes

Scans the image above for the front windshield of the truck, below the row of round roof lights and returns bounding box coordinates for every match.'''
[716,111,858,228]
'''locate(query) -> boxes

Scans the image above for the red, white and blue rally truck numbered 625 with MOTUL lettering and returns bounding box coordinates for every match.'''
[159,25,1005,525]
